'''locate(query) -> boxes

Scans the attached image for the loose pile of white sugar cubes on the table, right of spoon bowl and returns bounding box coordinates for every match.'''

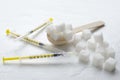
[73,30,116,71]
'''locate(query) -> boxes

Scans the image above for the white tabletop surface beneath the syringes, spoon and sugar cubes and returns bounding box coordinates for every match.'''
[0,0,120,80]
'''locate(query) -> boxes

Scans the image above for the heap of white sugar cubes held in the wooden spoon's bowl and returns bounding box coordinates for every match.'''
[47,23,73,41]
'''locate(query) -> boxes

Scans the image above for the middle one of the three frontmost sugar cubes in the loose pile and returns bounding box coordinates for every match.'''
[92,53,104,68]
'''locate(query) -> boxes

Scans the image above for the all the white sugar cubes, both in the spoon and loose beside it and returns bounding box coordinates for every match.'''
[47,23,116,71]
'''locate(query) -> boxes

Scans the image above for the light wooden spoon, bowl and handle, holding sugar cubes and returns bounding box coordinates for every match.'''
[47,21,104,45]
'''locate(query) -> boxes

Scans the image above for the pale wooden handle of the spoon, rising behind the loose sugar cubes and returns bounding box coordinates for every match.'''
[73,21,105,33]
